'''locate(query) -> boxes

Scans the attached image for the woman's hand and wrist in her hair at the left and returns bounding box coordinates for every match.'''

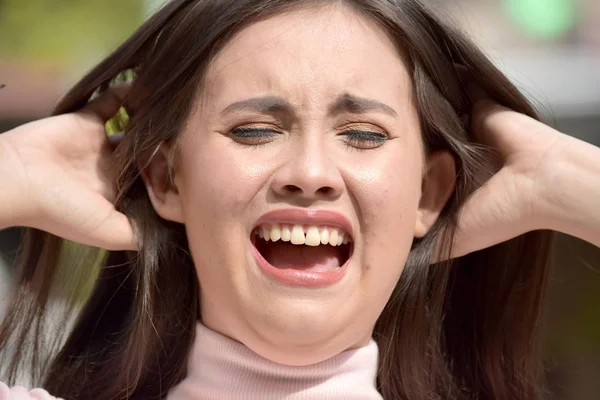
[0,86,136,250]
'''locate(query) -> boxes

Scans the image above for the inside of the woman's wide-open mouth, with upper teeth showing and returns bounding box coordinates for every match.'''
[251,224,353,272]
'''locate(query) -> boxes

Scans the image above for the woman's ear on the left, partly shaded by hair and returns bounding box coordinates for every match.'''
[142,143,184,223]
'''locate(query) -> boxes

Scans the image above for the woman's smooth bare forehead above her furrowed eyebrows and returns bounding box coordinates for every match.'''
[204,5,410,111]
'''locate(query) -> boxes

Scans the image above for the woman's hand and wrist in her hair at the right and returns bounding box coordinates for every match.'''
[453,96,600,257]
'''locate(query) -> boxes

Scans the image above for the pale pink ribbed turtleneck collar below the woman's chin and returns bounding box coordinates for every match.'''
[168,324,381,400]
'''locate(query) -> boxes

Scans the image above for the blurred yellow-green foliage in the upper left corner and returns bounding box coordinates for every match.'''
[0,0,145,65]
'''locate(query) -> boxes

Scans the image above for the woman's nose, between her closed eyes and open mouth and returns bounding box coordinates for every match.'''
[271,141,344,201]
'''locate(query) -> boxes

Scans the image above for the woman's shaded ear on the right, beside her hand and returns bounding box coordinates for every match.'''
[415,151,456,238]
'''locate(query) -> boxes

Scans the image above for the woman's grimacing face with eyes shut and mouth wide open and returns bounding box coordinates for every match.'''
[151,6,450,365]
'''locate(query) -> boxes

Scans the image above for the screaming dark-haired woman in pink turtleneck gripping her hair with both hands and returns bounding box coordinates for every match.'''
[0,0,600,400]
